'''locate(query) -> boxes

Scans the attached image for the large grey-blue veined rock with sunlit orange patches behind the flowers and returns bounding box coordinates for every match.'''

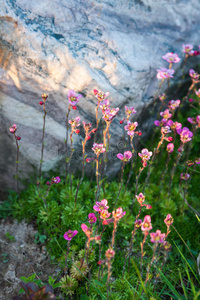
[0,0,200,187]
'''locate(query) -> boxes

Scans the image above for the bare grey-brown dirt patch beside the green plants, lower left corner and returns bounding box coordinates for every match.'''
[0,220,64,300]
